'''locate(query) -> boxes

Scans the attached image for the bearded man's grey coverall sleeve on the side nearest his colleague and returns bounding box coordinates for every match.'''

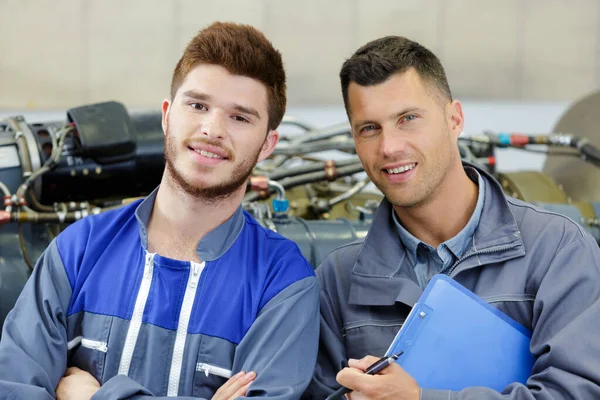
[92,248,319,400]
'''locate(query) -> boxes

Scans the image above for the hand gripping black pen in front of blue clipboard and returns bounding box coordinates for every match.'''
[336,356,421,400]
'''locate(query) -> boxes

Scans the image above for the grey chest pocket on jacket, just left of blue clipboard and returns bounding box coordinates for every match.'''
[342,319,404,359]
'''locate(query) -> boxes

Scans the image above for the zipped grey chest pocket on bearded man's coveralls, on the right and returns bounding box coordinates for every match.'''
[192,337,235,399]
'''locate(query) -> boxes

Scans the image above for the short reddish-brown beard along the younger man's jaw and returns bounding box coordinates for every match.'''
[164,130,260,202]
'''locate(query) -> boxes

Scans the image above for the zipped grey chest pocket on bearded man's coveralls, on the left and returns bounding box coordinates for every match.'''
[67,318,112,383]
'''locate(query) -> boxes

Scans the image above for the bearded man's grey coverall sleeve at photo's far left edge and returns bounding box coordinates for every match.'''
[0,241,72,400]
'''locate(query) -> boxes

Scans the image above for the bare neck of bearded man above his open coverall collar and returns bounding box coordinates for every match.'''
[148,176,245,261]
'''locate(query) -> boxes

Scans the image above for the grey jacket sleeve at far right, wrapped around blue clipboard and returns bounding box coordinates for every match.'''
[421,234,600,400]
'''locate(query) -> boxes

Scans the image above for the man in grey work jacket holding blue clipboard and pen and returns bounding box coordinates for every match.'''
[305,37,600,400]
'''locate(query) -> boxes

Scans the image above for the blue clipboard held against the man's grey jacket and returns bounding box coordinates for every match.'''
[386,274,534,392]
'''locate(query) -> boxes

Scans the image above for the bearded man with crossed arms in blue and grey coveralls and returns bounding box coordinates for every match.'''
[0,23,319,400]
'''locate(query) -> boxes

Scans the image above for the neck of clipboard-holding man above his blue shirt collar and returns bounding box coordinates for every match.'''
[394,164,478,247]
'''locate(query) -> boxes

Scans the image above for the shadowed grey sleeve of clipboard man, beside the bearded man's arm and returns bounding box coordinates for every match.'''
[302,255,348,400]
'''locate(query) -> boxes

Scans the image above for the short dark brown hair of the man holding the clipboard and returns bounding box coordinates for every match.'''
[340,36,452,115]
